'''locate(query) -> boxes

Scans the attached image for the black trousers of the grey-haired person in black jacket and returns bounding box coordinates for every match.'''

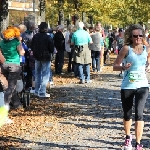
[55,51,64,74]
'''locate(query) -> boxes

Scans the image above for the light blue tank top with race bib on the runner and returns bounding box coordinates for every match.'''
[121,46,149,89]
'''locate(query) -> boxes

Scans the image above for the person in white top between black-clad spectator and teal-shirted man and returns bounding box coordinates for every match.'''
[65,25,73,73]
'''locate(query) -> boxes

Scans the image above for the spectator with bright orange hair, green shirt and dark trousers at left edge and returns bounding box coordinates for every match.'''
[0,27,25,108]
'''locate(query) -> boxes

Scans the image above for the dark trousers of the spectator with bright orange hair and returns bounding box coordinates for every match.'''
[2,64,21,106]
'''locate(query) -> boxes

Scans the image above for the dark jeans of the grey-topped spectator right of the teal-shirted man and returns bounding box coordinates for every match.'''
[91,50,100,71]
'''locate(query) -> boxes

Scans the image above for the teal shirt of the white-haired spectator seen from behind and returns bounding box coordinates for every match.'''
[71,29,92,45]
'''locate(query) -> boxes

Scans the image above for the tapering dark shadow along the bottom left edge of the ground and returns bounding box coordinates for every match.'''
[0,136,100,150]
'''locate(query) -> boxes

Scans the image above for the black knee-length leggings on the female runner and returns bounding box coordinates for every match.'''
[121,87,149,121]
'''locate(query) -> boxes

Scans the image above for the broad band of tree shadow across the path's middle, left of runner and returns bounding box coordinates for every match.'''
[11,85,122,118]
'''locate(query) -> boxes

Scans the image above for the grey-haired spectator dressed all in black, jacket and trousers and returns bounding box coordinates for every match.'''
[54,25,65,74]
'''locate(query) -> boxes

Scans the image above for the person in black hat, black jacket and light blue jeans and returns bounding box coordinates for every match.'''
[31,22,54,97]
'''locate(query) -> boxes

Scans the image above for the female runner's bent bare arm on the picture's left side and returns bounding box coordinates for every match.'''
[113,46,132,71]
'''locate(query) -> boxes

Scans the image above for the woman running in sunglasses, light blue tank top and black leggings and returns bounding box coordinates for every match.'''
[113,24,150,150]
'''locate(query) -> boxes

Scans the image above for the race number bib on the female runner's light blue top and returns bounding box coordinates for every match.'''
[129,71,146,82]
